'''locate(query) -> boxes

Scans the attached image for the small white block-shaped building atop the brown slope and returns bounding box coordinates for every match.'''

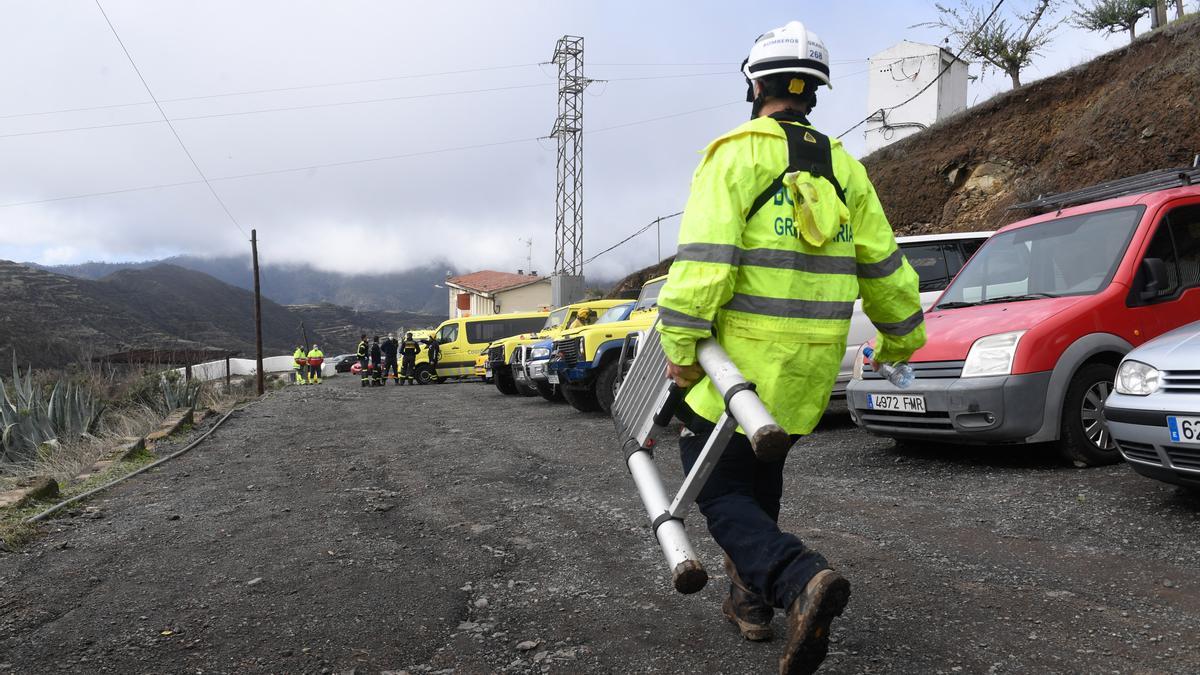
[865,40,968,154]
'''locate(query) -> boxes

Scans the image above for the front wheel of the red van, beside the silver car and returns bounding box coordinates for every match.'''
[1058,363,1121,467]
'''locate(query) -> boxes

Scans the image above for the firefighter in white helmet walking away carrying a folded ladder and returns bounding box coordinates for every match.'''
[659,22,925,674]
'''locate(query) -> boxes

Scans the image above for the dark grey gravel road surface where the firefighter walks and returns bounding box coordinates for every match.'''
[0,377,1200,674]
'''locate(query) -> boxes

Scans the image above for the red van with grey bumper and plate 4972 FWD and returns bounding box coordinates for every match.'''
[847,168,1200,466]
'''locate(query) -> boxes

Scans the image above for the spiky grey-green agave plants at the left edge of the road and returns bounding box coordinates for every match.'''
[0,359,104,464]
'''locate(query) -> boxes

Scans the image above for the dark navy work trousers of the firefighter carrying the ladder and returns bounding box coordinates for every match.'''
[679,422,829,610]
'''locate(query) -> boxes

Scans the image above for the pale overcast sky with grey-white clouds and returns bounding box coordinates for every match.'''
[0,0,1161,276]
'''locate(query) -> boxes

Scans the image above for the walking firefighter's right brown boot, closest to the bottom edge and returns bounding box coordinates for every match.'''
[779,569,850,675]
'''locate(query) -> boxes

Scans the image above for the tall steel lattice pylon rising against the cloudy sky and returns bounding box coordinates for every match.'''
[550,35,592,306]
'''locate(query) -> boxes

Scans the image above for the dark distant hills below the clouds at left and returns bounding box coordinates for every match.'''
[0,261,439,368]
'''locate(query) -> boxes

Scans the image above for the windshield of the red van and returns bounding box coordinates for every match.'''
[934,207,1146,309]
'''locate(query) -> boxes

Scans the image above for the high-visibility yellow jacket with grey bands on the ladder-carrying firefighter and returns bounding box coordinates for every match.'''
[659,118,925,434]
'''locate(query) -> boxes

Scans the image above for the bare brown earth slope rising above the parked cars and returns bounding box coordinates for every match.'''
[863,16,1200,234]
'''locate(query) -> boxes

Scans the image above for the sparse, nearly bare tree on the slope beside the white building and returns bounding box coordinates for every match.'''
[919,0,1061,89]
